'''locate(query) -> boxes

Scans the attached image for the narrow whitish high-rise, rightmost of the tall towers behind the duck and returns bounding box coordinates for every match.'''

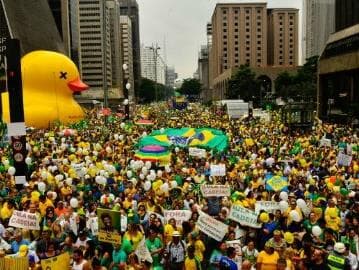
[120,16,135,101]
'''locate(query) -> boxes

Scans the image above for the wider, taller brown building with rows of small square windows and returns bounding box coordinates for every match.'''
[211,3,267,78]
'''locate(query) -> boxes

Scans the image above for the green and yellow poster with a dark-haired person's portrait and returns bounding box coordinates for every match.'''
[97,208,121,244]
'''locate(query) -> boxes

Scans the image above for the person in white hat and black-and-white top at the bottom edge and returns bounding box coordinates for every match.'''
[166,231,186,270]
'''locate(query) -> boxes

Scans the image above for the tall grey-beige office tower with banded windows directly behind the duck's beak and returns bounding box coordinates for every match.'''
[79,0,112,92]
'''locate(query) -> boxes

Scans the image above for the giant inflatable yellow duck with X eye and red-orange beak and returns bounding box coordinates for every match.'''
[2,51,89,128]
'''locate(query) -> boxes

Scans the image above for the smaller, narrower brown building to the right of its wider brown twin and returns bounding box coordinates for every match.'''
[267,8,299,67]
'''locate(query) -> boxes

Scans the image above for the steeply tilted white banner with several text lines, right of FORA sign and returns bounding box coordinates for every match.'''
[196,212,228,242]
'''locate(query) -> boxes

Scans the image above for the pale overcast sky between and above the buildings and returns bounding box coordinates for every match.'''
[137,0,302,78]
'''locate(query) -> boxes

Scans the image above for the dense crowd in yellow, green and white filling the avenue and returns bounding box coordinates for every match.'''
[0,104,359,270]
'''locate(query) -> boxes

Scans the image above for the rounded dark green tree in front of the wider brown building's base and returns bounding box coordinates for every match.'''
[226,65,260,102]
